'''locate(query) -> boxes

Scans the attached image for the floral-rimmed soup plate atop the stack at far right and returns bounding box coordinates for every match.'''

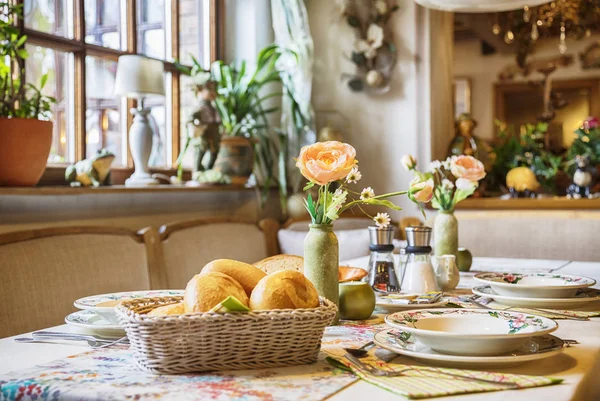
[474,272,596,298]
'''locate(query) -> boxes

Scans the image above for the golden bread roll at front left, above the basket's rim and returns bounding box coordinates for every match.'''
[183,272,248,313]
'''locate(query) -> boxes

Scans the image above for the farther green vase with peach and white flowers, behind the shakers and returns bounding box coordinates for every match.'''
[402,155,485,256]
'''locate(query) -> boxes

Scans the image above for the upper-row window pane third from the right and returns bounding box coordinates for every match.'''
[84,0,124,50]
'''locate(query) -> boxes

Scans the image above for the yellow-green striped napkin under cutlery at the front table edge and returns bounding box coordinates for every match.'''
[324,348,562,399]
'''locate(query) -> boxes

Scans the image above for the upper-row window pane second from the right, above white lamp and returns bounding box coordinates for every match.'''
[137,0,170,60]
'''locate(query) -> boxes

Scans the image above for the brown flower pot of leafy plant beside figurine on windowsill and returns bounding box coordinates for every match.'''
[214,136,254,185]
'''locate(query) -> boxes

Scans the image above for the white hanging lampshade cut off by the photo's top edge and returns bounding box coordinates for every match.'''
[415,0,549,13]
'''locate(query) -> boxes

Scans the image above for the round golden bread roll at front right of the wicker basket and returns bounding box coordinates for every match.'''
[250,270,319,310]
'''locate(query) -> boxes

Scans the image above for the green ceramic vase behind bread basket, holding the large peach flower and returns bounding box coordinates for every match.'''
[304,224,340,323]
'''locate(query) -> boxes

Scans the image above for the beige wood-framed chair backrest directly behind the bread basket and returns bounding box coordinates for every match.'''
[154,218,279,289]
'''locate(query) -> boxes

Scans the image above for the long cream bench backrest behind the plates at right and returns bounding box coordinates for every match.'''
[456,208,600,262]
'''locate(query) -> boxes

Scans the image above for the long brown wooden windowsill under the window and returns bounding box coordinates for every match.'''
[0,185,255,196]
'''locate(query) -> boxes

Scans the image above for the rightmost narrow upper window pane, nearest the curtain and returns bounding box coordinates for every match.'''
[179,0,210,68]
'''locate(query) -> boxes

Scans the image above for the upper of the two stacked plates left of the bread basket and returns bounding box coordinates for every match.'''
[73,290,184,323]
